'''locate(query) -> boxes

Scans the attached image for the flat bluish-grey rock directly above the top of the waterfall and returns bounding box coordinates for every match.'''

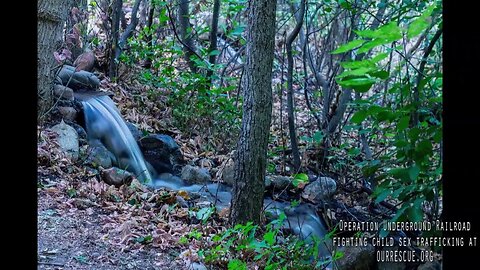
[58,65,100,91]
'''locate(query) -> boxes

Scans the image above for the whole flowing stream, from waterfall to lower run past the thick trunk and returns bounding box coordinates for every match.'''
[82,96,329,262]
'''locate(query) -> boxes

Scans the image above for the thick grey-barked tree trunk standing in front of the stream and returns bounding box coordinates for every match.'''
[230,0,277,224]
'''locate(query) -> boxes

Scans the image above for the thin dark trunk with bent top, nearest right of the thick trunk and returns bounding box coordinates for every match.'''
[286,1,305,172]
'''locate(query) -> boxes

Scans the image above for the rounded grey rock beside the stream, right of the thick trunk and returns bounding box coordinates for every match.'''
[302,177,337,204]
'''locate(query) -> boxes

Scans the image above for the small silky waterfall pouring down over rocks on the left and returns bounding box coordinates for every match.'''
[82,96,152,184]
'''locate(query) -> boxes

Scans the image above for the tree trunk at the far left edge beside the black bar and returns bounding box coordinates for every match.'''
[37,0,71,115]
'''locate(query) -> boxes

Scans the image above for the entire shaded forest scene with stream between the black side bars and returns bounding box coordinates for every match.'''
[37,0,442,269]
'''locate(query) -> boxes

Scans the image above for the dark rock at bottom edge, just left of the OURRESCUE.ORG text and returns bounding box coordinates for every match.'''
[336,244,375,270]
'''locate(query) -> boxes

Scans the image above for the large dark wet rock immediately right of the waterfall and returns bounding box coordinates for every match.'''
[138,134,185,174]
